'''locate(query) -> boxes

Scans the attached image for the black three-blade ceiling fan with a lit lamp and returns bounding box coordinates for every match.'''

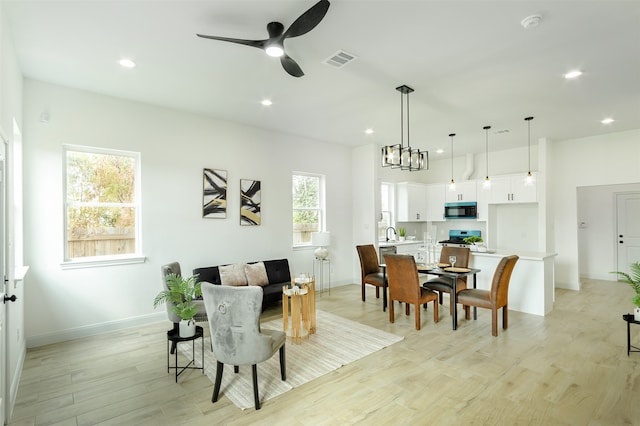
[196,0,329,77]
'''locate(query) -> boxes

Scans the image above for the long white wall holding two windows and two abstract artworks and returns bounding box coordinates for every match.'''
[24,80,353,346]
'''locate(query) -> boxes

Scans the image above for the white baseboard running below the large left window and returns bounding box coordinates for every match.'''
[27,312,167,348]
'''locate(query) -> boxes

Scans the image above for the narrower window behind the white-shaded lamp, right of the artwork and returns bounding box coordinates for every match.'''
[291,173,325,246]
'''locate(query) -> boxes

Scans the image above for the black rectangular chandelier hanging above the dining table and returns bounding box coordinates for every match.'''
[382,84,429,172]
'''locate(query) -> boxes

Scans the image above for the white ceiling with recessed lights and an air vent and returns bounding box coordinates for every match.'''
[2,0,640,158]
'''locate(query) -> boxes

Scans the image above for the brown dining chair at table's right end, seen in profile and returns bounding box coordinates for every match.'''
[458,255,518,336]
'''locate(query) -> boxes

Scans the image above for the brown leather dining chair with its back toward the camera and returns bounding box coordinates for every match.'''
[384,254,438,330]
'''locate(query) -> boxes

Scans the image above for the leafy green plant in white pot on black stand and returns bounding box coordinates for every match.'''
[153,274,202,337]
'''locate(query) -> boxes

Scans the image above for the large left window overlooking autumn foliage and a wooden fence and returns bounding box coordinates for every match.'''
[64,146,141,263]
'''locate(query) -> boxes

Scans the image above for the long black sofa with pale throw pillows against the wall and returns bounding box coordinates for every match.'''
[193,259,291,310]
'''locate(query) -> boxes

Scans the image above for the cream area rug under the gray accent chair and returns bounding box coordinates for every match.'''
[179,311,404,410]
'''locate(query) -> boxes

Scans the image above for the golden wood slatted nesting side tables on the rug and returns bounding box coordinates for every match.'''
[282,279,316,343]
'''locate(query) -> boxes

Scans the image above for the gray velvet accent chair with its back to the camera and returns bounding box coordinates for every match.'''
[202,282,287,410]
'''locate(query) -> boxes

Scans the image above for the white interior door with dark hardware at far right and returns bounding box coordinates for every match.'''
[616,192,640,273]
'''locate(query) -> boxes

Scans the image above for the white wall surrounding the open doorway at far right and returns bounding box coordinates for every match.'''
[548,129,640,290]
